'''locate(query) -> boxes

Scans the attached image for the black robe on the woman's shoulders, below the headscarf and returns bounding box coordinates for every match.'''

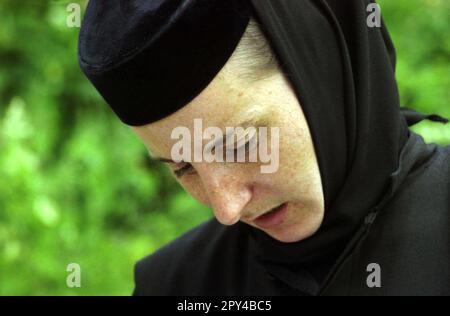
[134,134,450,295]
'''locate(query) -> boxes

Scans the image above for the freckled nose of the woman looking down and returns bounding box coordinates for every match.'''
[198,164,253,225]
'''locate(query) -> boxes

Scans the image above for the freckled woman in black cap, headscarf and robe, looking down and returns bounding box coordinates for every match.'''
[79,0,450,295]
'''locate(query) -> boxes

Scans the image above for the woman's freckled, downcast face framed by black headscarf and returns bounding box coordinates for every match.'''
[133,67,324,242]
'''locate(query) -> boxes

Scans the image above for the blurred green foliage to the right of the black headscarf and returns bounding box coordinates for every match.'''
[377,0,450,144]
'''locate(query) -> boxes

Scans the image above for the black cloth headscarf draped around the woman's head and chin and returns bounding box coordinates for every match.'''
[248,0,448,283]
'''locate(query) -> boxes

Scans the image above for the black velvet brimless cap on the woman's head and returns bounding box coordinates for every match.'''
[78,0,251,126]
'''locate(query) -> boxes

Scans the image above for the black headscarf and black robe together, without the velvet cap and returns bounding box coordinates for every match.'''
[131,0,450,295]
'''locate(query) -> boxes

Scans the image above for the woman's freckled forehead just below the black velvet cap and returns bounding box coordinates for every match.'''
[129,77,270,156]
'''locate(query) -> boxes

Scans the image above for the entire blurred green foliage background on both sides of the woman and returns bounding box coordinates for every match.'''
[0,0,450,295]
